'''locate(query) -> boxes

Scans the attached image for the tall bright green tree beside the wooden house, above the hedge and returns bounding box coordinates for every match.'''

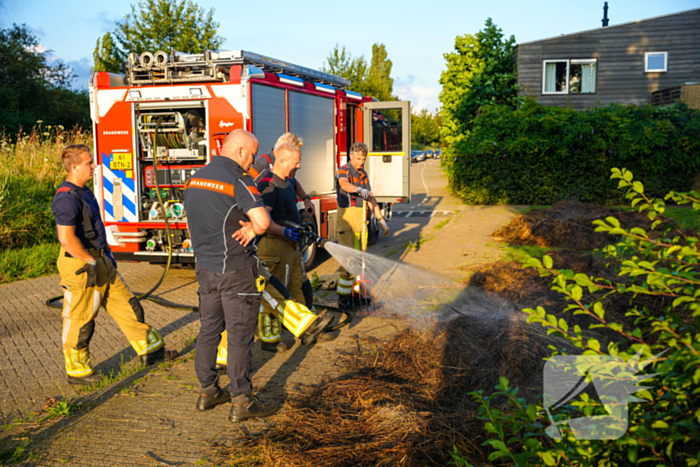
[440,18,517,144]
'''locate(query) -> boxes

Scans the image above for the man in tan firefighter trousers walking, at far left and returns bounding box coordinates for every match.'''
[52,144,177,385]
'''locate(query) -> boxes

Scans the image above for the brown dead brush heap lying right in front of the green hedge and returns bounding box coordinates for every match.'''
[493,201,651,251]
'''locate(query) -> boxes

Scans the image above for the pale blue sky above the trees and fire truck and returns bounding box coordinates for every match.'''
[0,0,700,112]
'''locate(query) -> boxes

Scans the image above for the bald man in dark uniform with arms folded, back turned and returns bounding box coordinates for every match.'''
[185,130,276,422]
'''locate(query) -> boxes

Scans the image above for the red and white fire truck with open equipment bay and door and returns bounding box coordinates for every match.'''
[90,51,411,264]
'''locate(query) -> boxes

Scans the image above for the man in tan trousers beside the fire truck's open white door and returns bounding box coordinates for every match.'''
[335,143,389,310]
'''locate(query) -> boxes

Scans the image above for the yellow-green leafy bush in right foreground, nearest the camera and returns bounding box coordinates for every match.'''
[464,169,700,466]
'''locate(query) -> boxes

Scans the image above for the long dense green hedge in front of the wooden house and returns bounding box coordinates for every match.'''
[443,99,700,204]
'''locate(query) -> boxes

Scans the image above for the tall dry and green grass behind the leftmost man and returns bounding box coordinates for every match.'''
[0,122,92,284]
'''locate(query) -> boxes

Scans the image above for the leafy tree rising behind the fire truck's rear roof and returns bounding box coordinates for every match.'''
[93,0,224,71]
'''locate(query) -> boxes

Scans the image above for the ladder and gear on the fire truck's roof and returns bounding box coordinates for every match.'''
[124,49,351,89]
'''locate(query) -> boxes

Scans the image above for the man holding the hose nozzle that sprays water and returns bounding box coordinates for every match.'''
[258,143,332,352]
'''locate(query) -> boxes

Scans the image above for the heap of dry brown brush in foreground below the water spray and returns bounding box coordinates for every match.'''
[229,316,566,466]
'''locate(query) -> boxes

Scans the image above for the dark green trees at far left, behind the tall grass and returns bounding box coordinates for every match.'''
[0,24,90,136]
